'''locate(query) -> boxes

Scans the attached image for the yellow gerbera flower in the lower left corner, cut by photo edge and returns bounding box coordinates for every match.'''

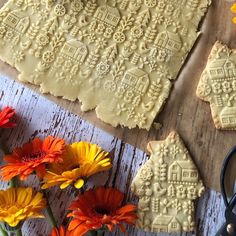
[0,188,46,227]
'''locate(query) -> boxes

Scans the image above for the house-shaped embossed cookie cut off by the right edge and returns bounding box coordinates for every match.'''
[197,42,236,130]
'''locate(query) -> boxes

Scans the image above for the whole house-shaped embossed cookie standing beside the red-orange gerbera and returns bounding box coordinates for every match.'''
[131,132,204,232]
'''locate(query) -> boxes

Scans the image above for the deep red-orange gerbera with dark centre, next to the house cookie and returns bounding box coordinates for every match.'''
[68,187,137,236]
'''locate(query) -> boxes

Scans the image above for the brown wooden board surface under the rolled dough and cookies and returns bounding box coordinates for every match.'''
[0,0,236,190]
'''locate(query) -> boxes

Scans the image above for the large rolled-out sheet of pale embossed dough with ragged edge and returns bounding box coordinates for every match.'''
[0,0,210,129]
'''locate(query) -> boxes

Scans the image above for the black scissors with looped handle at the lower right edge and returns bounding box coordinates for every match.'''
[216,146,236,236]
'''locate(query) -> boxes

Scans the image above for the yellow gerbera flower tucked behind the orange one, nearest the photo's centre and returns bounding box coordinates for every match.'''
[42,142,112,189]
